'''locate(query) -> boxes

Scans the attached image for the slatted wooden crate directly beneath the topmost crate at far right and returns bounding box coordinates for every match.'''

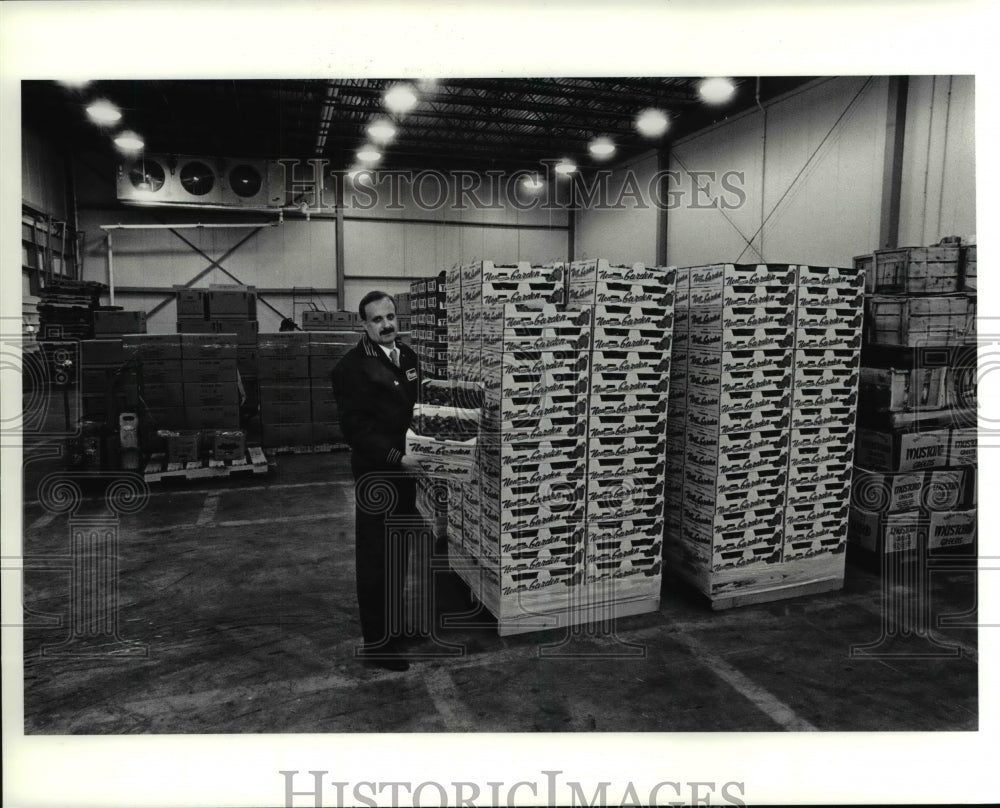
[865,294,976,347]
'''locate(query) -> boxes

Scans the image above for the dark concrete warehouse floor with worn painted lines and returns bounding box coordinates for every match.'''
[24,438,978,734]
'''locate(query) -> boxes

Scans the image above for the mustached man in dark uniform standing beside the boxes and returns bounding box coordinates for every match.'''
[332,291,420,671]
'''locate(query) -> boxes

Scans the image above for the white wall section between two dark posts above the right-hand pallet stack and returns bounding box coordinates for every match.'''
[667,77,889,266]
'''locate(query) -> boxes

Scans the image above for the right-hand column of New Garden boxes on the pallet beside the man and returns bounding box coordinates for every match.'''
[567,259,676,608]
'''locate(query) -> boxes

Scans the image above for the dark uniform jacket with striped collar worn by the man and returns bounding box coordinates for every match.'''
[331,334,420,475]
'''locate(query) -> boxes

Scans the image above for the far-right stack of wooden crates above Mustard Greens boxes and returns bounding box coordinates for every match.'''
[850,239,977,566]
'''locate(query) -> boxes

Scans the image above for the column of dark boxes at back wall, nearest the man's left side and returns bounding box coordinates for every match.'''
[257,331,313,447]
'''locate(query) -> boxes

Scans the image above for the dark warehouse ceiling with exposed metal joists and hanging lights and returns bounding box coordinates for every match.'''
[22,77,809,177]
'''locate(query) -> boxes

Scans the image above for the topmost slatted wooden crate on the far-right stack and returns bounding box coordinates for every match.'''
[854,244,960,295]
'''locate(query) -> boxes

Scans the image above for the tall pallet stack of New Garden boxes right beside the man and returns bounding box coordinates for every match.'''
[445,261,673,634]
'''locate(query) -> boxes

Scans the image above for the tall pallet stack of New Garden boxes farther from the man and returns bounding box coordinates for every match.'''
[666,264,862,608]
